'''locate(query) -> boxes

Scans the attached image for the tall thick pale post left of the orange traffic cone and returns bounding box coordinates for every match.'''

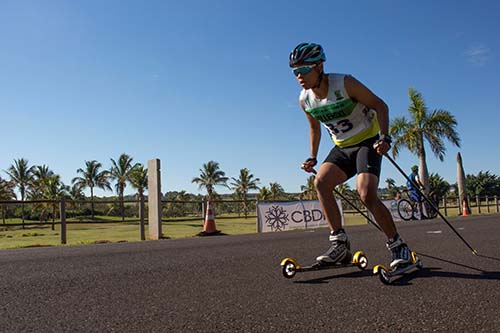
[148,159,162,240]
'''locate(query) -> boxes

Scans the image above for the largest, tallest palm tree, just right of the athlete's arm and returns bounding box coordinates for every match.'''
[389,88,460,194]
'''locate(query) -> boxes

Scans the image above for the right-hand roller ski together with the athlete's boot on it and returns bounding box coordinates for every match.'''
[373,235,423,285]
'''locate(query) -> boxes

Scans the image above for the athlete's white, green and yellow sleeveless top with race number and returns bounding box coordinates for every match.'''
[299,74,380,148]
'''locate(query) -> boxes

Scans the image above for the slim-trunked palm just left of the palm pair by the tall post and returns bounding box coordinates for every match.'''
[71,160,111,219]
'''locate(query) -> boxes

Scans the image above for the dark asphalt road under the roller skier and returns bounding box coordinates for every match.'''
[0,215,500,332]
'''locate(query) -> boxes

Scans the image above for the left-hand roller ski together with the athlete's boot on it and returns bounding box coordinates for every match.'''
[281,229,368,279]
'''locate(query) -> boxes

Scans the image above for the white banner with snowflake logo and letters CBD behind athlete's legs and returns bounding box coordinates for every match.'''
[257,200,344,232]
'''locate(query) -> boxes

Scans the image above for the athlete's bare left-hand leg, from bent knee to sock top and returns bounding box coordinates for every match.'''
[314,162,347,232]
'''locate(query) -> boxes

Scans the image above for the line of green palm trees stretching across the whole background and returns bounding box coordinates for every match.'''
[0,88,500,221]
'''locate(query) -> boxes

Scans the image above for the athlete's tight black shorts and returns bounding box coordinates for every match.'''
[323,134,382,179]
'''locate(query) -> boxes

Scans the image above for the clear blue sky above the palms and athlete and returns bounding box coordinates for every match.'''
[0,0,500,195]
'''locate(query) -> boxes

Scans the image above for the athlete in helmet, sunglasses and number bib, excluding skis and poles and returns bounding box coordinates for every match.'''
[289,43,411,267]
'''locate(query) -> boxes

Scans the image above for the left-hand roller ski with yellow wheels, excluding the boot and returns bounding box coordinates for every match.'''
[281,251,368,279]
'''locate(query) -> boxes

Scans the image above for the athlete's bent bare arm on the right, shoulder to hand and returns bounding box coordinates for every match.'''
[344,75,390,154]
